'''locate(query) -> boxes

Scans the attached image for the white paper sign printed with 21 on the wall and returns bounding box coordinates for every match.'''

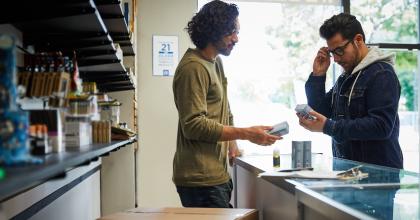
[153,35,178,76]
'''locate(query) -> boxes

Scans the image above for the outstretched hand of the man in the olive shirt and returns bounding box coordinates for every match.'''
[246,126,283,146]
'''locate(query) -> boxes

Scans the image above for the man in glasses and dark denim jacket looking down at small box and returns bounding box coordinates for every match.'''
[298,13,403,169]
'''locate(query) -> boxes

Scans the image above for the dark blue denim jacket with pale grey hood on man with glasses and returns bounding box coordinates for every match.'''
[305,48,403,169]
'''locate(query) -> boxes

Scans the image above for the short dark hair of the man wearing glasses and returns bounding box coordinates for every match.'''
[319,13,365,41]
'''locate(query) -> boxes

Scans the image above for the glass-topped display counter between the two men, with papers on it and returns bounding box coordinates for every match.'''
[234,154,419,220]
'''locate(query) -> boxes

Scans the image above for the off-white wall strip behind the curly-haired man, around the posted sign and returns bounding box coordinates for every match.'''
[137,0,197,207]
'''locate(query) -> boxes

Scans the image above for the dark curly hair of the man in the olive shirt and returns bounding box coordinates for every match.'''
[185,0,239,49]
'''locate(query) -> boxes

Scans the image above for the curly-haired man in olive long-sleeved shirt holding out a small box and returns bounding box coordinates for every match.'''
[172,0,281,208]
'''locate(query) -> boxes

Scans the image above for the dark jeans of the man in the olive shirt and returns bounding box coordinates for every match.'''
[176,179,233,208]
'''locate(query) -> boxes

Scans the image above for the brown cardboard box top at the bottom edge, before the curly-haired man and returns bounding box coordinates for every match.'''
[100,208,258,220]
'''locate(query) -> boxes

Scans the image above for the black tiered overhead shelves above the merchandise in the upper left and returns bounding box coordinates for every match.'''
[0,0,135,92]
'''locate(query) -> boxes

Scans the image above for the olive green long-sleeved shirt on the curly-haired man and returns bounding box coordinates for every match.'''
[172,49,233,186]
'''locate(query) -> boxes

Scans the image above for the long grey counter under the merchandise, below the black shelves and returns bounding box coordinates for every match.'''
[0,137,136,219]
